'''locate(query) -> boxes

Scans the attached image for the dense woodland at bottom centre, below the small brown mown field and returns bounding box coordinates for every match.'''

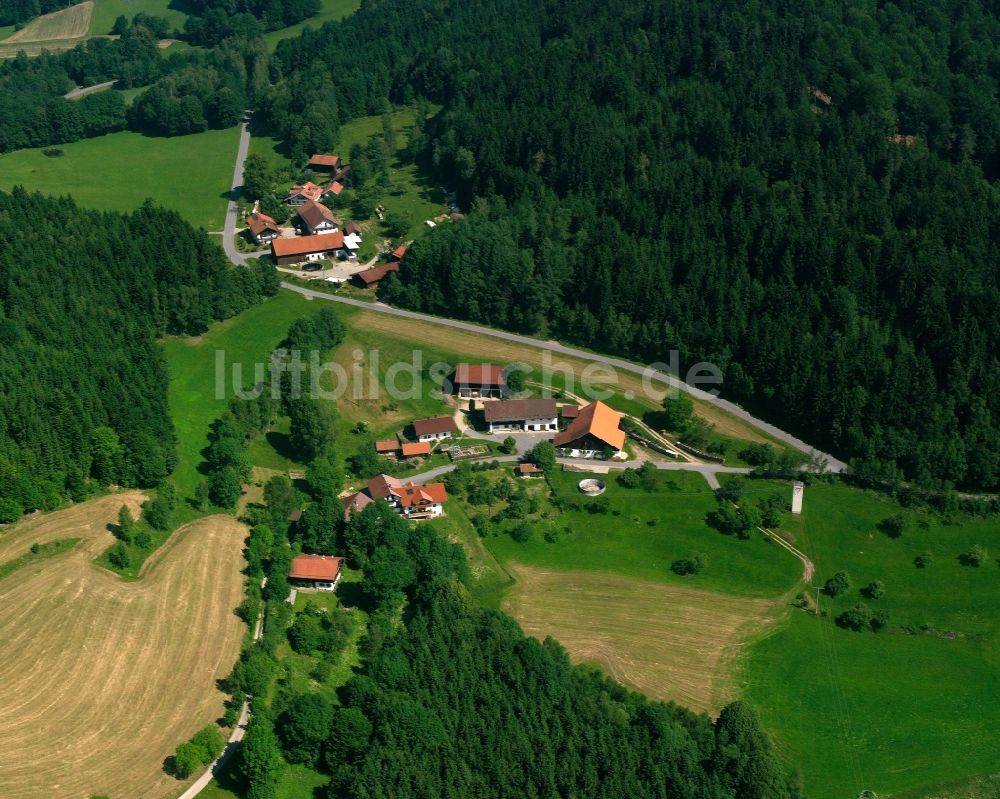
[228,466,801,799]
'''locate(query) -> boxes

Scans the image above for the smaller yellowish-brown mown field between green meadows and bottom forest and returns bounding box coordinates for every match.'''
[503,564,776,713]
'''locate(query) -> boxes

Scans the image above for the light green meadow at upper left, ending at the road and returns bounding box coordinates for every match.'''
[0,128,239,230]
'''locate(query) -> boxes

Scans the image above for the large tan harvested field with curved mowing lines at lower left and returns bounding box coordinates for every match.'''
[0,492,245,799]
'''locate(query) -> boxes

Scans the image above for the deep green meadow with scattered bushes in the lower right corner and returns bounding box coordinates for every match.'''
[745,485,1000,799]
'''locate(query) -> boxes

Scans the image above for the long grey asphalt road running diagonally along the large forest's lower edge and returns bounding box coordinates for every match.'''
[284,280,847,472]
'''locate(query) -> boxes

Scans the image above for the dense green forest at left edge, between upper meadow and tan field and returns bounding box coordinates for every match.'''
[0,188,277,522]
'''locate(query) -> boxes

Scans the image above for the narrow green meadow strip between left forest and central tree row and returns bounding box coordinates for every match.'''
[163,291,320,498]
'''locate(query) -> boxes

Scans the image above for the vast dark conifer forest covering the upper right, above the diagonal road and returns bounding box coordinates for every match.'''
[258,0,1000,489]
